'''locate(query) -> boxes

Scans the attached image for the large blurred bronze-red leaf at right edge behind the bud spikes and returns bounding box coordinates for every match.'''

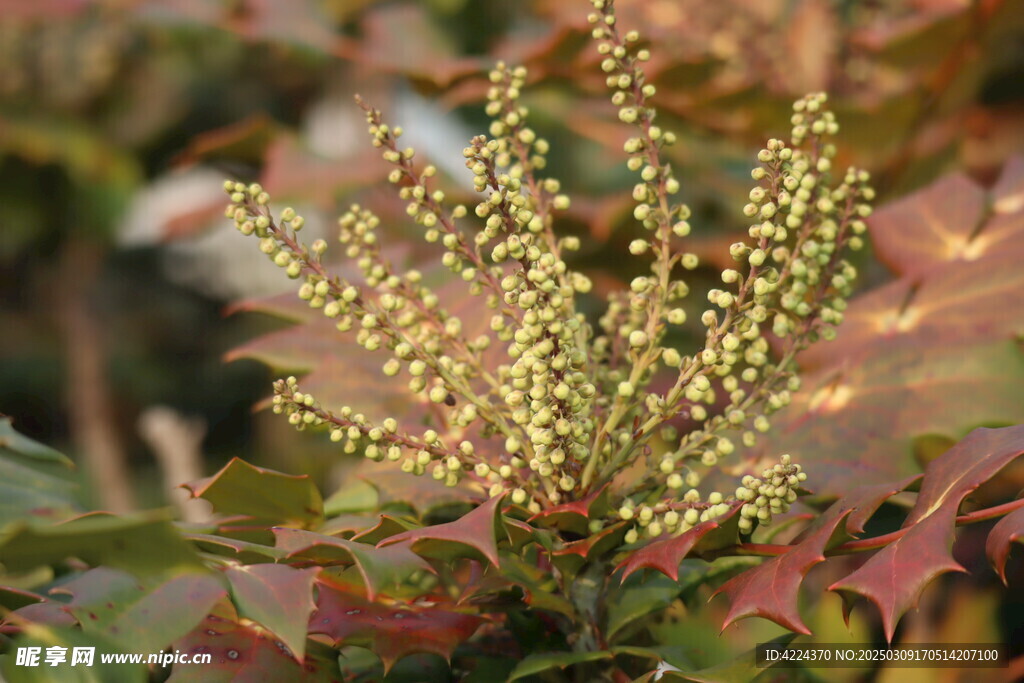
[765,160,1024,495]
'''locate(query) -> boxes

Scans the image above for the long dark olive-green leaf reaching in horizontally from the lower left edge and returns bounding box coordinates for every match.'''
[0,512,204,575]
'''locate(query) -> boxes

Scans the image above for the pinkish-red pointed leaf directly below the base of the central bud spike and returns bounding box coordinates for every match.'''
[378,496,507,566]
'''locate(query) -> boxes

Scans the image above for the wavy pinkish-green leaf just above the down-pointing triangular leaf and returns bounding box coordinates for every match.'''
[273,528,433,600]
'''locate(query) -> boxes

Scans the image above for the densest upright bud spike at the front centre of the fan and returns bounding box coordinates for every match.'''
[464,136,596,502]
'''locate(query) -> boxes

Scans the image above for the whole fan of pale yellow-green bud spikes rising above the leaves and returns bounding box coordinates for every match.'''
[224,0,873,532]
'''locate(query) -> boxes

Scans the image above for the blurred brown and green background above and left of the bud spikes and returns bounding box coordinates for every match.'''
[0,0,1024,518]
